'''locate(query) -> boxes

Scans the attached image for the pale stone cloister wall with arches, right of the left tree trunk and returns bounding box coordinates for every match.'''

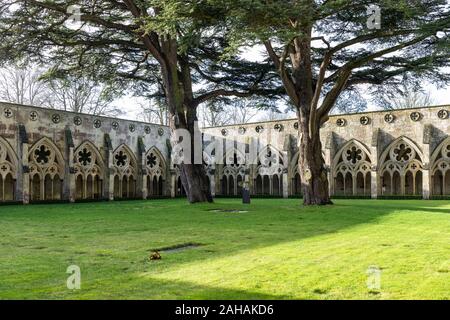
[204,106,450,199]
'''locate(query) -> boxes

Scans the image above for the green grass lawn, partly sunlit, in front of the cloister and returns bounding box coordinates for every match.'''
[0,199,450,299]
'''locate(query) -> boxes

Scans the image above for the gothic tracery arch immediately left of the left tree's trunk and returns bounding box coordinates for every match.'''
[145,147,166,197]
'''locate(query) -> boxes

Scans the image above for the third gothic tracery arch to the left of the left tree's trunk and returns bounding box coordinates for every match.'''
[73,140,105,199]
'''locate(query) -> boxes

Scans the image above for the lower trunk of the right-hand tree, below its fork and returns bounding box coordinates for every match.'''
[298,114,333,206]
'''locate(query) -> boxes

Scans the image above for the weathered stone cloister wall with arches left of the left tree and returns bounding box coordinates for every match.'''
[0,103,171,203]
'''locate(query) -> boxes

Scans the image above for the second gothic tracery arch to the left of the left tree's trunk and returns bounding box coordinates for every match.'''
[112,144,138,199]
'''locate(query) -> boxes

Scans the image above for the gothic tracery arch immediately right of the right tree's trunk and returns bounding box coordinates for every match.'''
[331,139,372,196]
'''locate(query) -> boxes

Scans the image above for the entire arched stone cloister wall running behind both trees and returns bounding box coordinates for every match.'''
[0,103,450,203]
